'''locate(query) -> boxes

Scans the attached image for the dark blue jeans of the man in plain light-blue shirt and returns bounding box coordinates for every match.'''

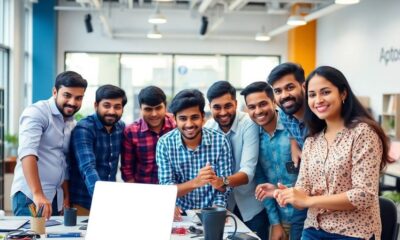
[233,207,269,240]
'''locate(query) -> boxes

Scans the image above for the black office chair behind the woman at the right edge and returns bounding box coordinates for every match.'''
[379,197,399,240]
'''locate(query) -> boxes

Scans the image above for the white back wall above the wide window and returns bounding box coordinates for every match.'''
[58,10,287,71]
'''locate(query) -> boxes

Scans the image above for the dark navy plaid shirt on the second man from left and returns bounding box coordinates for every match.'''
[69,114,125,209]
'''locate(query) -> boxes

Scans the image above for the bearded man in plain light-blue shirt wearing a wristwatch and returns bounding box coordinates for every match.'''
[205,81,268,240]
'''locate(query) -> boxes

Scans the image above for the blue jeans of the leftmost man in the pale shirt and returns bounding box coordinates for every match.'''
[12,192,60,216]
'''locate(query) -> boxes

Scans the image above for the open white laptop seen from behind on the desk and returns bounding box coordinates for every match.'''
[85,181,177,240]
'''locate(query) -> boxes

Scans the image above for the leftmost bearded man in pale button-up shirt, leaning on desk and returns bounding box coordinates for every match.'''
[11,71,87,219]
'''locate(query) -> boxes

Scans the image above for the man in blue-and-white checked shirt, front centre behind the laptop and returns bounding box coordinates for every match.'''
[156,90,232,221]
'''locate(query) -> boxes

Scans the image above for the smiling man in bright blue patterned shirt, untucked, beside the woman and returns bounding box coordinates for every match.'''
[241,82,307,240]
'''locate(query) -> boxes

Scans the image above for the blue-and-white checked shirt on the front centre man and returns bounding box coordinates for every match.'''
[156,128,233,210]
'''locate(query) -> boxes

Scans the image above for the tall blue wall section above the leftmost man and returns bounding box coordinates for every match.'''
[32,0,57,102]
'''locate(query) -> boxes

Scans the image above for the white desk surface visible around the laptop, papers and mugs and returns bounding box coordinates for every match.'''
[0,211,257,240]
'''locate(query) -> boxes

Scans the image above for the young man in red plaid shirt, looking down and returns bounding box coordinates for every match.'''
[121,86,175,184]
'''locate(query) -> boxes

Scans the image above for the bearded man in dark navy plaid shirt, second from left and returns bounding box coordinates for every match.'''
[69,85,127,216]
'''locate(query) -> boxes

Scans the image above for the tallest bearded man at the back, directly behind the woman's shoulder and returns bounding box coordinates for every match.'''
[268,62,308,167]
